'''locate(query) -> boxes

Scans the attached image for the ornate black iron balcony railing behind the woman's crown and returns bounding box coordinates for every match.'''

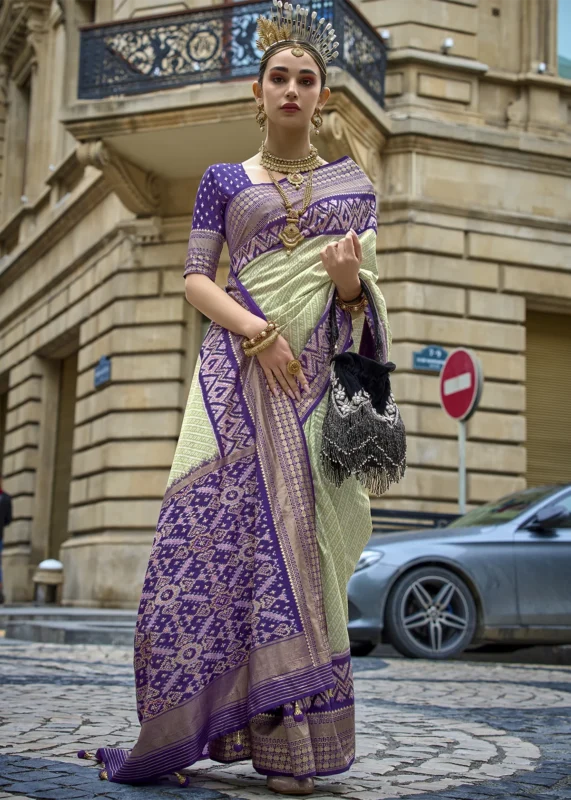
[78,0,386,105]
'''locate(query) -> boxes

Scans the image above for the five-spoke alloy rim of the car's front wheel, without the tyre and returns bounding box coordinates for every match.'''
[400,575,470,654]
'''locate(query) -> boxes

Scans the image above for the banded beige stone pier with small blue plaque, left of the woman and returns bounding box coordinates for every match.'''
[61,220,189,607]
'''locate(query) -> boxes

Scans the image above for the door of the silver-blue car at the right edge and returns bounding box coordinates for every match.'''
[514,492,571,628]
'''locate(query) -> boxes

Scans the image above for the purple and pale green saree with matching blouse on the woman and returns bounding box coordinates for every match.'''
[92,158,389,783]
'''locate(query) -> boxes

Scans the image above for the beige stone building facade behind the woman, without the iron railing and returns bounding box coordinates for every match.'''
[0,0,571,606]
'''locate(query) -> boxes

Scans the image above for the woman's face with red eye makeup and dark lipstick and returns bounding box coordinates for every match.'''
[254,49,329,130]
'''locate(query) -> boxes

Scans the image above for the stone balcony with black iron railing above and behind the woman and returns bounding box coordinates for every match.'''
[62,0,391,215]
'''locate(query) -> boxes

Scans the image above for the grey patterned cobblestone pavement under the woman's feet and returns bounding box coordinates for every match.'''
[0,640,571,800]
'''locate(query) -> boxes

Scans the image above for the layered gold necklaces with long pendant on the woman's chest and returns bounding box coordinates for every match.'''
[261,144,319,256]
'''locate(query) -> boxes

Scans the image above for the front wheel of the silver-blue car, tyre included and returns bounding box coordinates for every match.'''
[385,567,477,659]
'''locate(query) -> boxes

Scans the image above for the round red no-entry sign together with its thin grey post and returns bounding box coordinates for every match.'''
[440,347,484,514]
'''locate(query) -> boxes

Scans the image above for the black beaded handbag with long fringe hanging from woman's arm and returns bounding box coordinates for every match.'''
[321,281,406,496]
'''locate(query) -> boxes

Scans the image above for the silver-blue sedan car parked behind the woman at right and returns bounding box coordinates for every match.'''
[348,486,571,659]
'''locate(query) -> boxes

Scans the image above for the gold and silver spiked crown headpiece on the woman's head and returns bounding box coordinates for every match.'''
[256,0,339,77]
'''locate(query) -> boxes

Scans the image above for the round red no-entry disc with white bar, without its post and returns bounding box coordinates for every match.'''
[440,347,484,422]
